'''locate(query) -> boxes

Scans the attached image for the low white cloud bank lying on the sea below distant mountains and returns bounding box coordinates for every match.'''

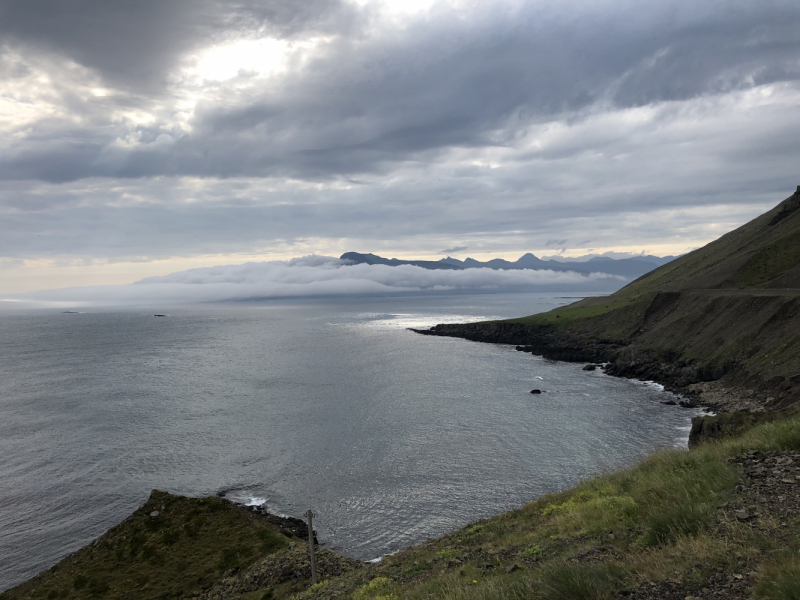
[5,255,627,305]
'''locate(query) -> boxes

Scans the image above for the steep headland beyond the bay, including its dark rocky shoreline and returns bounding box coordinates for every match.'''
[420,186,800,410]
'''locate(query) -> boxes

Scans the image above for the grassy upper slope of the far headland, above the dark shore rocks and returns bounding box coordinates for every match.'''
[500,189,800,390]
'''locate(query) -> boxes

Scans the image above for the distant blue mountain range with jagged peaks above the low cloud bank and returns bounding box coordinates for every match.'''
[339,252,675,279]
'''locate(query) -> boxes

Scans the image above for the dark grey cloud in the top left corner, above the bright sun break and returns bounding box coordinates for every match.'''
[0,0,350,92]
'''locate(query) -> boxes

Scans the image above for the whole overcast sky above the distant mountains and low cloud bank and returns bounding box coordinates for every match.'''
[0,0,800,292]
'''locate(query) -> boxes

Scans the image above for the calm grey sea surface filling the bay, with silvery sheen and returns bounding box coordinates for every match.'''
[0,294,693,590]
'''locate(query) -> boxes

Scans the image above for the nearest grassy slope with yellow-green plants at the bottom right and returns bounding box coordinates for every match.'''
[299,418,800,600]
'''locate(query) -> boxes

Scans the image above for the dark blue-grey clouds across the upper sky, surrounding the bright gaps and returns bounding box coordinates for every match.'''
[0,0,800,181]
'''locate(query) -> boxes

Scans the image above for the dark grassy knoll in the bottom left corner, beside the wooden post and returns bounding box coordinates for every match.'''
[0,490,289,600]
